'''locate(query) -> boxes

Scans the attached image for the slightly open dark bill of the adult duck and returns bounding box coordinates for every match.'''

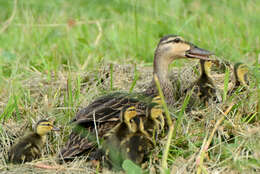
[185,46,213,60]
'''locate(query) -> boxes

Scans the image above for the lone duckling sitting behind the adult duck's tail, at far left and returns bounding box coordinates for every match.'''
[8,120,59,163]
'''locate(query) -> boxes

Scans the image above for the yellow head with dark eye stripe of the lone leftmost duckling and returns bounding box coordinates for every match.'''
[35,120,59,136]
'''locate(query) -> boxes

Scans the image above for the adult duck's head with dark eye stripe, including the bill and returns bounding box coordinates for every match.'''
[154,35,212,74]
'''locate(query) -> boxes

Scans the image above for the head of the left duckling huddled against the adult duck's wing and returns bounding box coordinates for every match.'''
[121,106,138,132]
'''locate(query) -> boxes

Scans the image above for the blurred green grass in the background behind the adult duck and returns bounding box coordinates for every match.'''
[0,0,260,78]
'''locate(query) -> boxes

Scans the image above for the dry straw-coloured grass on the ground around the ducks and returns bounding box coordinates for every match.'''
[0,59,260,173]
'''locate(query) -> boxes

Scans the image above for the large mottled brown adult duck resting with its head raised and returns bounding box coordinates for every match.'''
[60,35,212,160]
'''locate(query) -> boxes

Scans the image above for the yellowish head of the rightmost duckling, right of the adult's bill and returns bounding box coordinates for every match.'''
[234,63,249,86]
